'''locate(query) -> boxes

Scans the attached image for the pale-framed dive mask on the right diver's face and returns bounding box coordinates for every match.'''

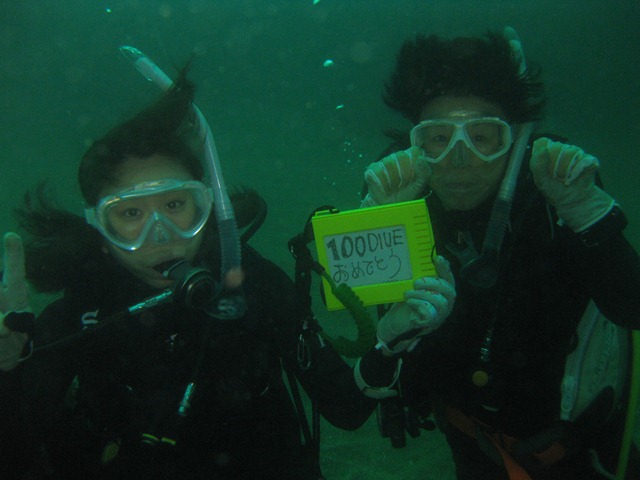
[411,117,513,163]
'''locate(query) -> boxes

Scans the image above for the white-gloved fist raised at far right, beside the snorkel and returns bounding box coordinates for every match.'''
[530,137,615,233]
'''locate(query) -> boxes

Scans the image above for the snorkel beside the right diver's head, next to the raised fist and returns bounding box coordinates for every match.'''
[460,27,534,288]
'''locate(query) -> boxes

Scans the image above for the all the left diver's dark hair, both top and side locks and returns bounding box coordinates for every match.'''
[15,68,203,292]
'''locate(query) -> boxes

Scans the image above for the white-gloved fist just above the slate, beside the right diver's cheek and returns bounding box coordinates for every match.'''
[360,147,431,208]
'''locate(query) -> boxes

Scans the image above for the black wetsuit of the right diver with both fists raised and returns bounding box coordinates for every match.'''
[362,169,640,480]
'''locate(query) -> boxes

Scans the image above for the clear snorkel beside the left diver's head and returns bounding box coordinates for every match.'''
[120,46,246,319]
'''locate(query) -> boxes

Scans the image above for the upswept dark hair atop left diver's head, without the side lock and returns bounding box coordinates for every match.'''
[78,68,203,205]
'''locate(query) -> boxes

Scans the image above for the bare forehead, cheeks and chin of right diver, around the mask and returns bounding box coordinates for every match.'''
[420,96,508,210]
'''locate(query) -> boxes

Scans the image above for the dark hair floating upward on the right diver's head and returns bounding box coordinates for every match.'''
[382,32,545,124]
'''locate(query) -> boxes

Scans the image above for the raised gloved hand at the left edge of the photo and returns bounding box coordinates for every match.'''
[0,233,33,371]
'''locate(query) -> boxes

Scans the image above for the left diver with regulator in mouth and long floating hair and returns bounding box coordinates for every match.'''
[0,58,375,480]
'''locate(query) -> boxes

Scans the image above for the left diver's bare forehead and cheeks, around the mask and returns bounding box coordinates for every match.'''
[100,155,202,288]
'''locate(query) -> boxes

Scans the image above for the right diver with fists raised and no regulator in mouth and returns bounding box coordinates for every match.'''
[355,29,640,480]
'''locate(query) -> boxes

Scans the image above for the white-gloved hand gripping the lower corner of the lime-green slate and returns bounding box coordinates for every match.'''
[377,256,456,354]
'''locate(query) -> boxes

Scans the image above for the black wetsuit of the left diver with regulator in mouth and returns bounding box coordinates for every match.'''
[0,247,374,480]
